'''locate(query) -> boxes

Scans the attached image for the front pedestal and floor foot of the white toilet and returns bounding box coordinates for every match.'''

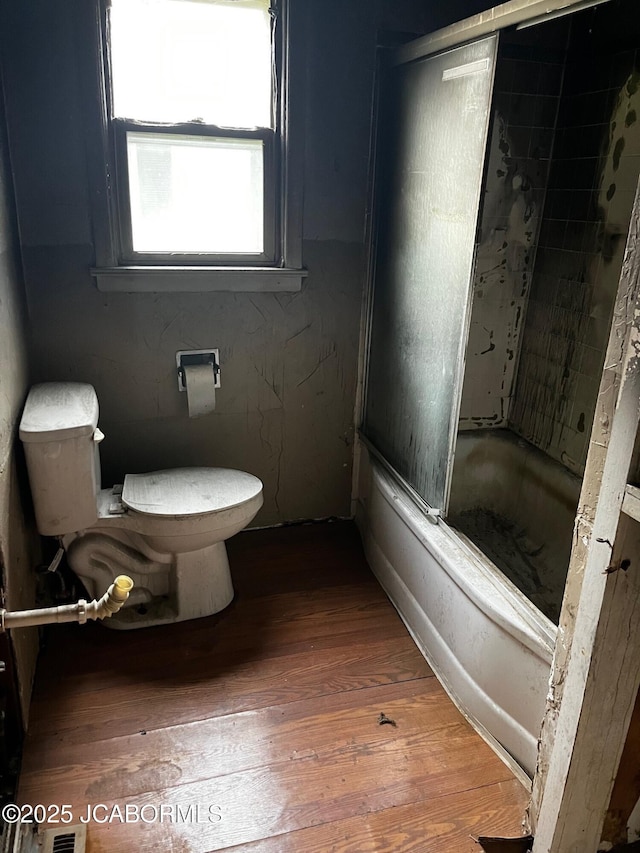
[103,542,233,630]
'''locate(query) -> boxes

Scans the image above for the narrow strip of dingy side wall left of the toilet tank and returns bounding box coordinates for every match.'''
[0,78,38,720]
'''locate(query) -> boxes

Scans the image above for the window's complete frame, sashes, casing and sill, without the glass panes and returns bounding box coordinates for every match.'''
[76,0,306,292]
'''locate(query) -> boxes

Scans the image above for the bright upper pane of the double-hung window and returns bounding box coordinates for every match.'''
[110,0,271,127]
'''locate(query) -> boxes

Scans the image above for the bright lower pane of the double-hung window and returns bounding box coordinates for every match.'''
[126,132,264,254]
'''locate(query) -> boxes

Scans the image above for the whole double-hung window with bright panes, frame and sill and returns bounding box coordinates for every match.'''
[87,0,303,290]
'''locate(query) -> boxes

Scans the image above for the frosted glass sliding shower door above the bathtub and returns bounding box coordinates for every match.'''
[364,36,496,509]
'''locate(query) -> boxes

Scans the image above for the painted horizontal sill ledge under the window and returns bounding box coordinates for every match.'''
[90,266,307,293]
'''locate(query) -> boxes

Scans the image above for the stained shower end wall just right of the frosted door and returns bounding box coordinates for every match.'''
[460,29,568,429]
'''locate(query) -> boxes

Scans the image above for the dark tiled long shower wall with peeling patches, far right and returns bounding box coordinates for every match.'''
[508,0,640,474]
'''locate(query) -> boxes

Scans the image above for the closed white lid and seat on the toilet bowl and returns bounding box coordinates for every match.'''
[122,468,262,518]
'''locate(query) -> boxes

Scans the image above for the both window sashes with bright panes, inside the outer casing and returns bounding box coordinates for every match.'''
[109,0,276,263]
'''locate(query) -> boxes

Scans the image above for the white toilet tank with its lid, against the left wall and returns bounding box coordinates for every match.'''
[20,382,102,536]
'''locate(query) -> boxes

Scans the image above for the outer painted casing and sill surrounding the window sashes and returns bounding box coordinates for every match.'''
[77,0,307,293]
